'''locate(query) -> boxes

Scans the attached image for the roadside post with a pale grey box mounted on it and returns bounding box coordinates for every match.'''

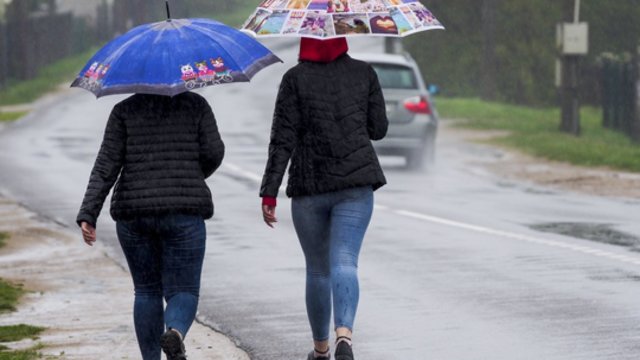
[556,0,589,136]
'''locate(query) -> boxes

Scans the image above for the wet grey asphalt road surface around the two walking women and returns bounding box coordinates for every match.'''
[0,40,640,360]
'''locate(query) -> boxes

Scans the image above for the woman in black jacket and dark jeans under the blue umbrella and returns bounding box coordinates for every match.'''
[77,93,224,360]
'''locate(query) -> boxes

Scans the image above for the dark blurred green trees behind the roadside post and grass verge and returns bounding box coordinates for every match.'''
[404,0,640,106]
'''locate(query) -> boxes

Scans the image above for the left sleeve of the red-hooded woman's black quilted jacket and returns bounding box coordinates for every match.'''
[260,73,301,197]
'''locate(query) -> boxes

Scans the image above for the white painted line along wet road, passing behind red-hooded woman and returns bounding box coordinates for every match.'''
[224,163,640,265]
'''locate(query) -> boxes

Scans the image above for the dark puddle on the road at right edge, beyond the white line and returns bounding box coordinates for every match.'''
[530,222,640,251]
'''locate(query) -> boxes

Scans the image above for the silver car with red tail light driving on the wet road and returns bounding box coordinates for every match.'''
[352,54,438,169]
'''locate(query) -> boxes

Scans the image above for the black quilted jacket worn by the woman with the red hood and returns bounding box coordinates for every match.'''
[260,54,388,197]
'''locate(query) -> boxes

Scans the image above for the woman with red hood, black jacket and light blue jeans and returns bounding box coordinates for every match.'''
[260,38,388,360]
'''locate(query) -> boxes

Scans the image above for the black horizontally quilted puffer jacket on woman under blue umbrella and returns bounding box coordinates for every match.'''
[77,93,224,226]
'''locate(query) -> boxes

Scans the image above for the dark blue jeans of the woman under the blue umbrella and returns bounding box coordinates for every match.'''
[116,215,206,360]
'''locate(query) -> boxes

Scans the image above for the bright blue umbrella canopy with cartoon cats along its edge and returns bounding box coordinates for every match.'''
[71,19,281,97]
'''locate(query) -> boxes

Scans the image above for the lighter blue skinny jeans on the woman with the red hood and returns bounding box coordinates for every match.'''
[292,187,373,341]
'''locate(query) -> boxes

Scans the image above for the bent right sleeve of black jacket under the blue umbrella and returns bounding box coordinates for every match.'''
[198,102,225,178]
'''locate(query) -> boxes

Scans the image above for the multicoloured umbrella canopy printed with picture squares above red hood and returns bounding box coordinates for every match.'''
[242,0,444,39]
